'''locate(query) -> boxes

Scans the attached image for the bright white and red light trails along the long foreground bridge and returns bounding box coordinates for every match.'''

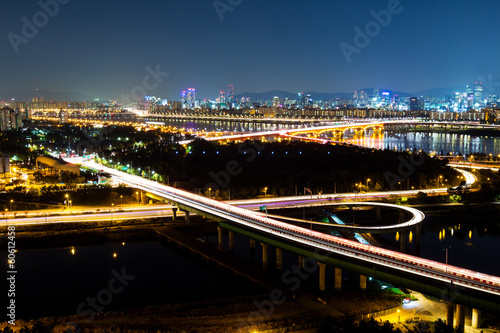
[73,161,500,296]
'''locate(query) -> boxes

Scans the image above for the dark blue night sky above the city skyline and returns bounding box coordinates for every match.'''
[0,0,500,99]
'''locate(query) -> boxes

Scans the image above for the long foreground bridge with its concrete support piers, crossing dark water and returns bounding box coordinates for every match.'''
[68,161,500,323]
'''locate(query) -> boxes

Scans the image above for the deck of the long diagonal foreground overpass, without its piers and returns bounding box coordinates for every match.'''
[75,161,500,313]
